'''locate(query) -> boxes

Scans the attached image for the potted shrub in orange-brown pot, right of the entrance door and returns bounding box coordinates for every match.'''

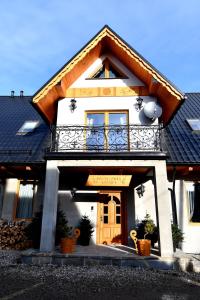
[137,214,156,256]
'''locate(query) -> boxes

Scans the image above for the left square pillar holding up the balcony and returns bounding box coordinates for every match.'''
[40,160,59,252]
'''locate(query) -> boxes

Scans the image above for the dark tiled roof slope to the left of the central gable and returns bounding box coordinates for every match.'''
[0,96,50,164]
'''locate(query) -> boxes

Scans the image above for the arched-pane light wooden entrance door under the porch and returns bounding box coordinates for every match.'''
[98,192,122,244]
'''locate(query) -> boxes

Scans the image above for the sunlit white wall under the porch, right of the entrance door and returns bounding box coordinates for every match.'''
[135,180,157,224]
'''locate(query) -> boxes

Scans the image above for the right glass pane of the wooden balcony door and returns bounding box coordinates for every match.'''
[108,113,128,151]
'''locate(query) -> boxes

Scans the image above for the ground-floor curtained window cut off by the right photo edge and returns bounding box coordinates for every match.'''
[186,183,200,223]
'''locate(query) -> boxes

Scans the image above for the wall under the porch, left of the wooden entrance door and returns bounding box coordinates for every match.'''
[58,191,97,244]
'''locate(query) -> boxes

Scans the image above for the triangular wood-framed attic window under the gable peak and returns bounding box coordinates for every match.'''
[89,59,127,79]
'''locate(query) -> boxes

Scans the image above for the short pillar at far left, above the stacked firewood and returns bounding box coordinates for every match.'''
[1,178,19,221]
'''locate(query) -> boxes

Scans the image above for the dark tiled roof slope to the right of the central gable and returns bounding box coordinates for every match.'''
[164,93,200,165]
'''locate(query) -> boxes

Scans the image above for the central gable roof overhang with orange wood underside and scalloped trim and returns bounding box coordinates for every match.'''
[33,25,184,123]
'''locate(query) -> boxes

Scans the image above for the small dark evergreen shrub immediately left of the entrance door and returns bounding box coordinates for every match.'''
[78,216,94,246]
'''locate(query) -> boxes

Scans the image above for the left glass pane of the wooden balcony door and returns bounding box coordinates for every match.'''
[86,113,105,151]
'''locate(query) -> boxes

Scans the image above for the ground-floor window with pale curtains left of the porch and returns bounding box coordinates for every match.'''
[16,182,35,219]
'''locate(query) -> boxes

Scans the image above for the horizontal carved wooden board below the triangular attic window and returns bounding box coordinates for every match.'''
[65,86,149,98]
